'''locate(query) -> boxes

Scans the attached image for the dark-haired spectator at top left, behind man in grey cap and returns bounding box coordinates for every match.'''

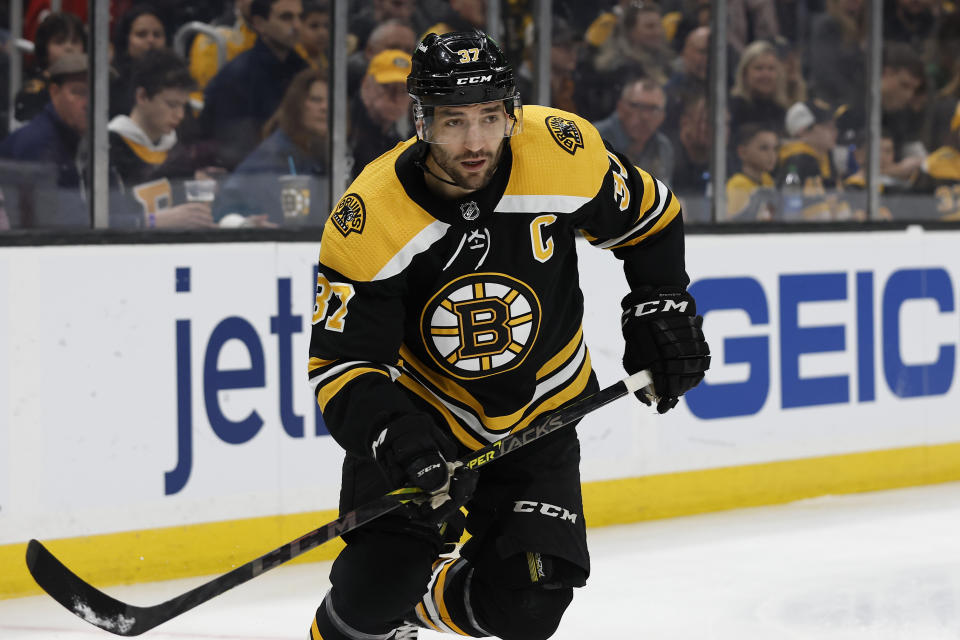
[13,12,87,122]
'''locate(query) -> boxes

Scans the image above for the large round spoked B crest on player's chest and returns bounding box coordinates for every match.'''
[420,273,540,380]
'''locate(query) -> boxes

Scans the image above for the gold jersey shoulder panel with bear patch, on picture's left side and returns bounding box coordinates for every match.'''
[320,139,442,282]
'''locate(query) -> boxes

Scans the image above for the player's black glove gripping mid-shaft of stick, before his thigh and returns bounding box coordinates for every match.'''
[372,415,477,524]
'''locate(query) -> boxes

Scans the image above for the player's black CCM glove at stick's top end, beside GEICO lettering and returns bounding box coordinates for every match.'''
[620,287,710,413]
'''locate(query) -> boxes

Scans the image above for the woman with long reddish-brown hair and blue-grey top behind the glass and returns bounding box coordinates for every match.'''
[214,69,329,226]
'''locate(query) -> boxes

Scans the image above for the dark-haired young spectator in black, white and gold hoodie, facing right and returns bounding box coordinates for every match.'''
[107,49,216,229]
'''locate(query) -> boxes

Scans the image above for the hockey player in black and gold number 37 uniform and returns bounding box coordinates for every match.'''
[309,31,709,640]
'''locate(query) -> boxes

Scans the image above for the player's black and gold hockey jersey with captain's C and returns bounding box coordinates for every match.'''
[309,106,689,456]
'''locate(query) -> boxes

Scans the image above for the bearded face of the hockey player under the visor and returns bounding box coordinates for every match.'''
[430,101,508,191]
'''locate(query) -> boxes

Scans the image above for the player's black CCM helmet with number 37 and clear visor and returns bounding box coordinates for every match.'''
[407,29,523,139]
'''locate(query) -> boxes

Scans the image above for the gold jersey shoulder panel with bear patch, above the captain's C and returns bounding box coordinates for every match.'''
[505,105,610,198]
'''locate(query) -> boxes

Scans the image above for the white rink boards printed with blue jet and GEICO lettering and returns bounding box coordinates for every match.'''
[0,232,960,543]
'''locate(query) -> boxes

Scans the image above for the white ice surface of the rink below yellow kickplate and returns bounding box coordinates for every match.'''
[0,483,960,640]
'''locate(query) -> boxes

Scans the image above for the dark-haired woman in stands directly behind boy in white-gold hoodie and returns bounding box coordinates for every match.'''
[110,4,167,117]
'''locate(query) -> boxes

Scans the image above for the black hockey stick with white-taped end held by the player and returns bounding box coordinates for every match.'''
[27,370,653,636]
